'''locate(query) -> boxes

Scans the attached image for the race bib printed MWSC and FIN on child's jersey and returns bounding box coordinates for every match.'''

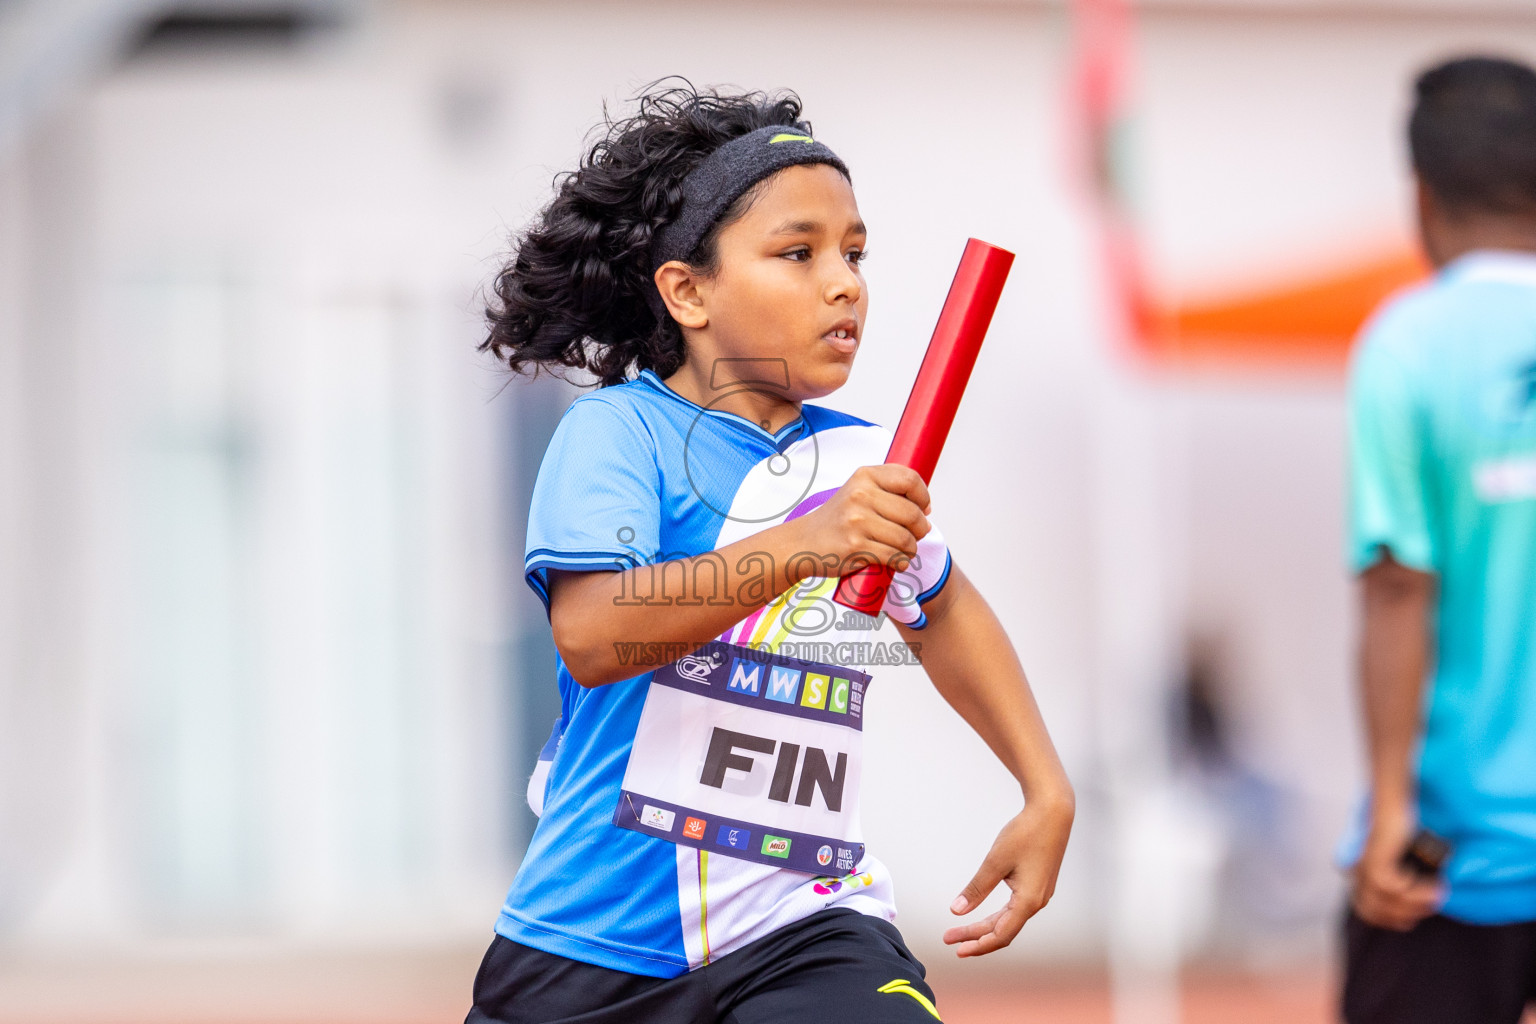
[613,640,869,875]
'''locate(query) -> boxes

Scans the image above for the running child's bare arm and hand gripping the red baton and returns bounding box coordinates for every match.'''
[548,465,929,686]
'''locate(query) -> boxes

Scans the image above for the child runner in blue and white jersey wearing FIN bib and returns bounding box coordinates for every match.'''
[468,88,1074,1024]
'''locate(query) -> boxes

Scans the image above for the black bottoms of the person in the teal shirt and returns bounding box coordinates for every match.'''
[1344,912,1536,1024]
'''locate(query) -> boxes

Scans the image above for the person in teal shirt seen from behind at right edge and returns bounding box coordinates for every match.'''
[1342,58,1536,1024]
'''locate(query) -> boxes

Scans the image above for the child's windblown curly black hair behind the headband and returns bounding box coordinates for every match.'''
[479,80,811,387]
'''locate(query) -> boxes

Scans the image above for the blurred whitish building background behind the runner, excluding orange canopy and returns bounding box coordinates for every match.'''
[0,0,1536,1024]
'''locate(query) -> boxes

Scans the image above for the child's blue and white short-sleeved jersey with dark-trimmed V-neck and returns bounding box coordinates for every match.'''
[496,372,949,978]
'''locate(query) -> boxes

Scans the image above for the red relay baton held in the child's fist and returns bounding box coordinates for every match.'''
[833,238,1014,616]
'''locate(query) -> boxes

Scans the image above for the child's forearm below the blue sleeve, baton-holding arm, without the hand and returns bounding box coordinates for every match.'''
[550,520,837,686]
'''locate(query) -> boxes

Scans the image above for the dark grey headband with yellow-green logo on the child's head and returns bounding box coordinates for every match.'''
[647,124,848,316]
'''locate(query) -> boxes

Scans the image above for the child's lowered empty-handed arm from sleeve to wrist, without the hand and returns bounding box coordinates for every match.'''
[902,565,1074,815]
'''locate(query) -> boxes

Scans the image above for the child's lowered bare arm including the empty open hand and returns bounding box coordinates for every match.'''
[897,565,1075,956]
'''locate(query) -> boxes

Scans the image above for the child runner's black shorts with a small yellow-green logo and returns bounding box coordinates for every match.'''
[465,910,938,1024]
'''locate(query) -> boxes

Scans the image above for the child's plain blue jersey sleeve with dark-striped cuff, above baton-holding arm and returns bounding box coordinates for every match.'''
[522,393,660,613]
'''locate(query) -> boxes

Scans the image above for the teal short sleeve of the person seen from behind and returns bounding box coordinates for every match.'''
[1349,319,1436,573]
